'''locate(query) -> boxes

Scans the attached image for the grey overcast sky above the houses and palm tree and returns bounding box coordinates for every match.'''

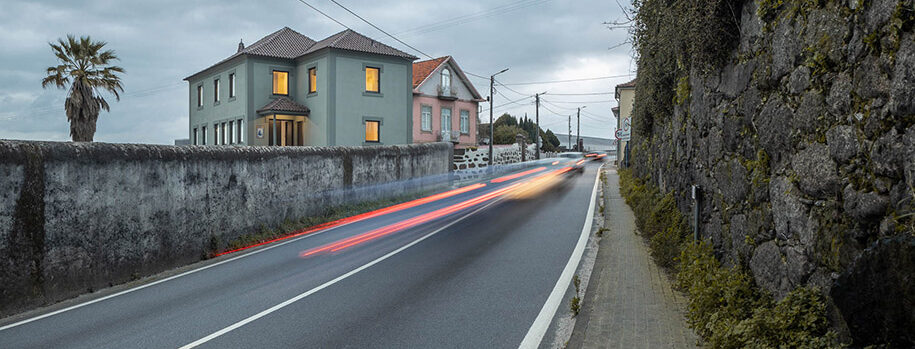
[0,0,635,144]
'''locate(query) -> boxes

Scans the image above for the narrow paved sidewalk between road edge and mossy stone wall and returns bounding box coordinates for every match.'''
[568,169,698,348]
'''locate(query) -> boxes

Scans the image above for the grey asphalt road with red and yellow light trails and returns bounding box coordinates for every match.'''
[0,159,598,348]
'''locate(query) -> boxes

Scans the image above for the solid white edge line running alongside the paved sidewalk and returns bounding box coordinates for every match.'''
[518,166,603,348]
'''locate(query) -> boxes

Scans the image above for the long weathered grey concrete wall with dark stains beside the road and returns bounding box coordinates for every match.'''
[0,140,453,316]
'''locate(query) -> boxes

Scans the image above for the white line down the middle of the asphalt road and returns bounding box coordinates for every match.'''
[180,198,500,349]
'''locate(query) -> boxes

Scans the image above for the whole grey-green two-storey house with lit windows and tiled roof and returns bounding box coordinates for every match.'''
[184,27,416,146]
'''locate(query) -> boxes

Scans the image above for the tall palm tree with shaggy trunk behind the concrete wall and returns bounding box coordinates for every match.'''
[41,35,124,142]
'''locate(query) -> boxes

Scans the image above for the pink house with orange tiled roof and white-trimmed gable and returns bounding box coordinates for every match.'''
[413,56,484,147]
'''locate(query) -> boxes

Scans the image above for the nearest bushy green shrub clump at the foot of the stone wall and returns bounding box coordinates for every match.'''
[677,243,838,348]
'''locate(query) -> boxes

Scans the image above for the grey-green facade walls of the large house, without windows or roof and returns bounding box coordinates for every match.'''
[188,49,413,146]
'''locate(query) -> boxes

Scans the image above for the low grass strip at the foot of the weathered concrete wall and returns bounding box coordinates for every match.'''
[206,191,431,258]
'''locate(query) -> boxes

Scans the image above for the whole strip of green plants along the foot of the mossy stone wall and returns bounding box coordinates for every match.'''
[619,170,840,348]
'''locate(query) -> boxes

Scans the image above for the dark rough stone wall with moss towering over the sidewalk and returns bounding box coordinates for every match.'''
[632,0,915,347]
